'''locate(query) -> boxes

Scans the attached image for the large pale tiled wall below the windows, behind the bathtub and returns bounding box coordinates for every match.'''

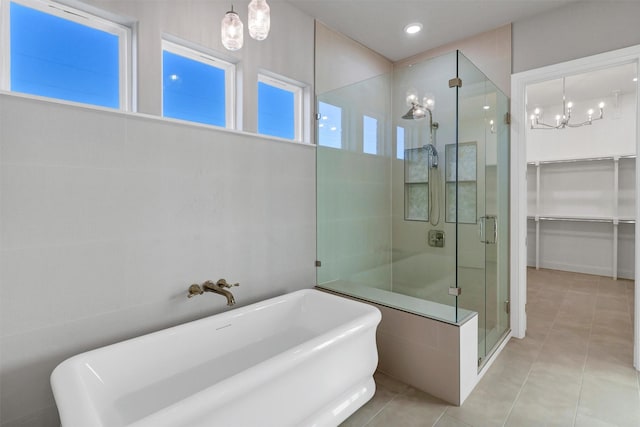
[0,94,315,427]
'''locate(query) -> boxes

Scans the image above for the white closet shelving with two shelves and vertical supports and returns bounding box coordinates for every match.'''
[527,155,636,280]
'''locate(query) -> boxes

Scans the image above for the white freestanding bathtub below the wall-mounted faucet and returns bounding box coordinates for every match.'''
[51,289,380,427]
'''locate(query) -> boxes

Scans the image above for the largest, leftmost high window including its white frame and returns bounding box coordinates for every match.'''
[1,0,131,110]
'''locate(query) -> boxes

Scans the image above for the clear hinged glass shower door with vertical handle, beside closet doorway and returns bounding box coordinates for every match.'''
[455,53,509,365]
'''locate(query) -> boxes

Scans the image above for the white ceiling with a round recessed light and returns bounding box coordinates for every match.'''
[286,0,579,62]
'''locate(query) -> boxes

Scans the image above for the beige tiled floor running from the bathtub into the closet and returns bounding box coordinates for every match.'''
[342,269,640,427]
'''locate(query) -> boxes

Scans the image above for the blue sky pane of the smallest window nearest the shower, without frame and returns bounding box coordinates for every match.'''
[258,82,296,139]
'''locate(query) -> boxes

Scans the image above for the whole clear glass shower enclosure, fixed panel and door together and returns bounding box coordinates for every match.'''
[317,51,509,365]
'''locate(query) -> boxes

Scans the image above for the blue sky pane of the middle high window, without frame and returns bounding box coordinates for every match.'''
[162,50,226,127]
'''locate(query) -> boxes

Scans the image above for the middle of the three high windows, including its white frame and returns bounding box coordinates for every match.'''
[162,40,235,128]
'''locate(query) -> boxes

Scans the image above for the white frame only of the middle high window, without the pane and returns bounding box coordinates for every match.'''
[160,35,237,129]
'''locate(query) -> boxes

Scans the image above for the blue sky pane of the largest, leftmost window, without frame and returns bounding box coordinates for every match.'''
[10,2,120,108]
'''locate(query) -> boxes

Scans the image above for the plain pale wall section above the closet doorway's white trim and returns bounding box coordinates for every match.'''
[512,0,640,73]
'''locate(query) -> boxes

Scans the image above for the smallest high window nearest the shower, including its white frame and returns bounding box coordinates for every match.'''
[258,74,303,141]
